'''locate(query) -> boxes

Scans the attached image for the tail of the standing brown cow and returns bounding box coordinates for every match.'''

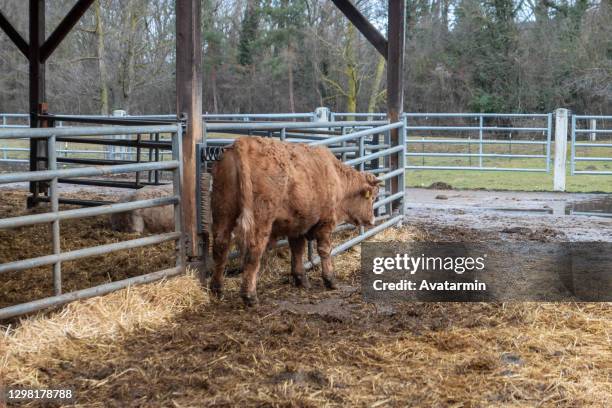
[234,143,255,249]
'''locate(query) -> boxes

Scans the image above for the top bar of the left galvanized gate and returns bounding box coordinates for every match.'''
[0,125,179,139]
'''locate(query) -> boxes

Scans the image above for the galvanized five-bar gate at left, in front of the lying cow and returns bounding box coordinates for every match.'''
[0,124,185,320]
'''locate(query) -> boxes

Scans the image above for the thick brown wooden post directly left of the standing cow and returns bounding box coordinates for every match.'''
[176,0,205,257]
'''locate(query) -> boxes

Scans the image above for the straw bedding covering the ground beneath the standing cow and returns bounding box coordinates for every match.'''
[0,190,612,407]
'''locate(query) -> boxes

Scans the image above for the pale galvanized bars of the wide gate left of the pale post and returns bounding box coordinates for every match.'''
[404,113,552,173]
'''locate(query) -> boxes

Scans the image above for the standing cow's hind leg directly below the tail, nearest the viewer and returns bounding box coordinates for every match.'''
[241,220,272,306]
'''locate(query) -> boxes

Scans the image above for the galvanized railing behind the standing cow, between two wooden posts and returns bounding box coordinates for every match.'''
[198,121,406,268]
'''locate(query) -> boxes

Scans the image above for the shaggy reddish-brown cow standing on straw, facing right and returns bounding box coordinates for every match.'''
[210,137,379,306]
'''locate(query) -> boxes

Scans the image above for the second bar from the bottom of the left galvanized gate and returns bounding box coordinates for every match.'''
[0,232,181,274]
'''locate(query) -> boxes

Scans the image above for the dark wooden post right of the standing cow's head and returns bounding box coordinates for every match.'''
[387,0,406,210]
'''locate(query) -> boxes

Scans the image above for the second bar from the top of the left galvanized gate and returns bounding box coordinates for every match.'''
[0,160,179,184]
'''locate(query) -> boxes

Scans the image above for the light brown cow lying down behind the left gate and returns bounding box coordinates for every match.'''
[111,184,174,233]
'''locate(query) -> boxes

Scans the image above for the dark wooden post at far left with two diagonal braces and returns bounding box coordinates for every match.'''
[28,0,47,207]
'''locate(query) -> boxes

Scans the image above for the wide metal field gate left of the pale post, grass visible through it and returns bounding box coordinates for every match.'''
[404,113,552,173]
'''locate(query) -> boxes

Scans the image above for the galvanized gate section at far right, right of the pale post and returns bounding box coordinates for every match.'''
[570,115,612,175]
